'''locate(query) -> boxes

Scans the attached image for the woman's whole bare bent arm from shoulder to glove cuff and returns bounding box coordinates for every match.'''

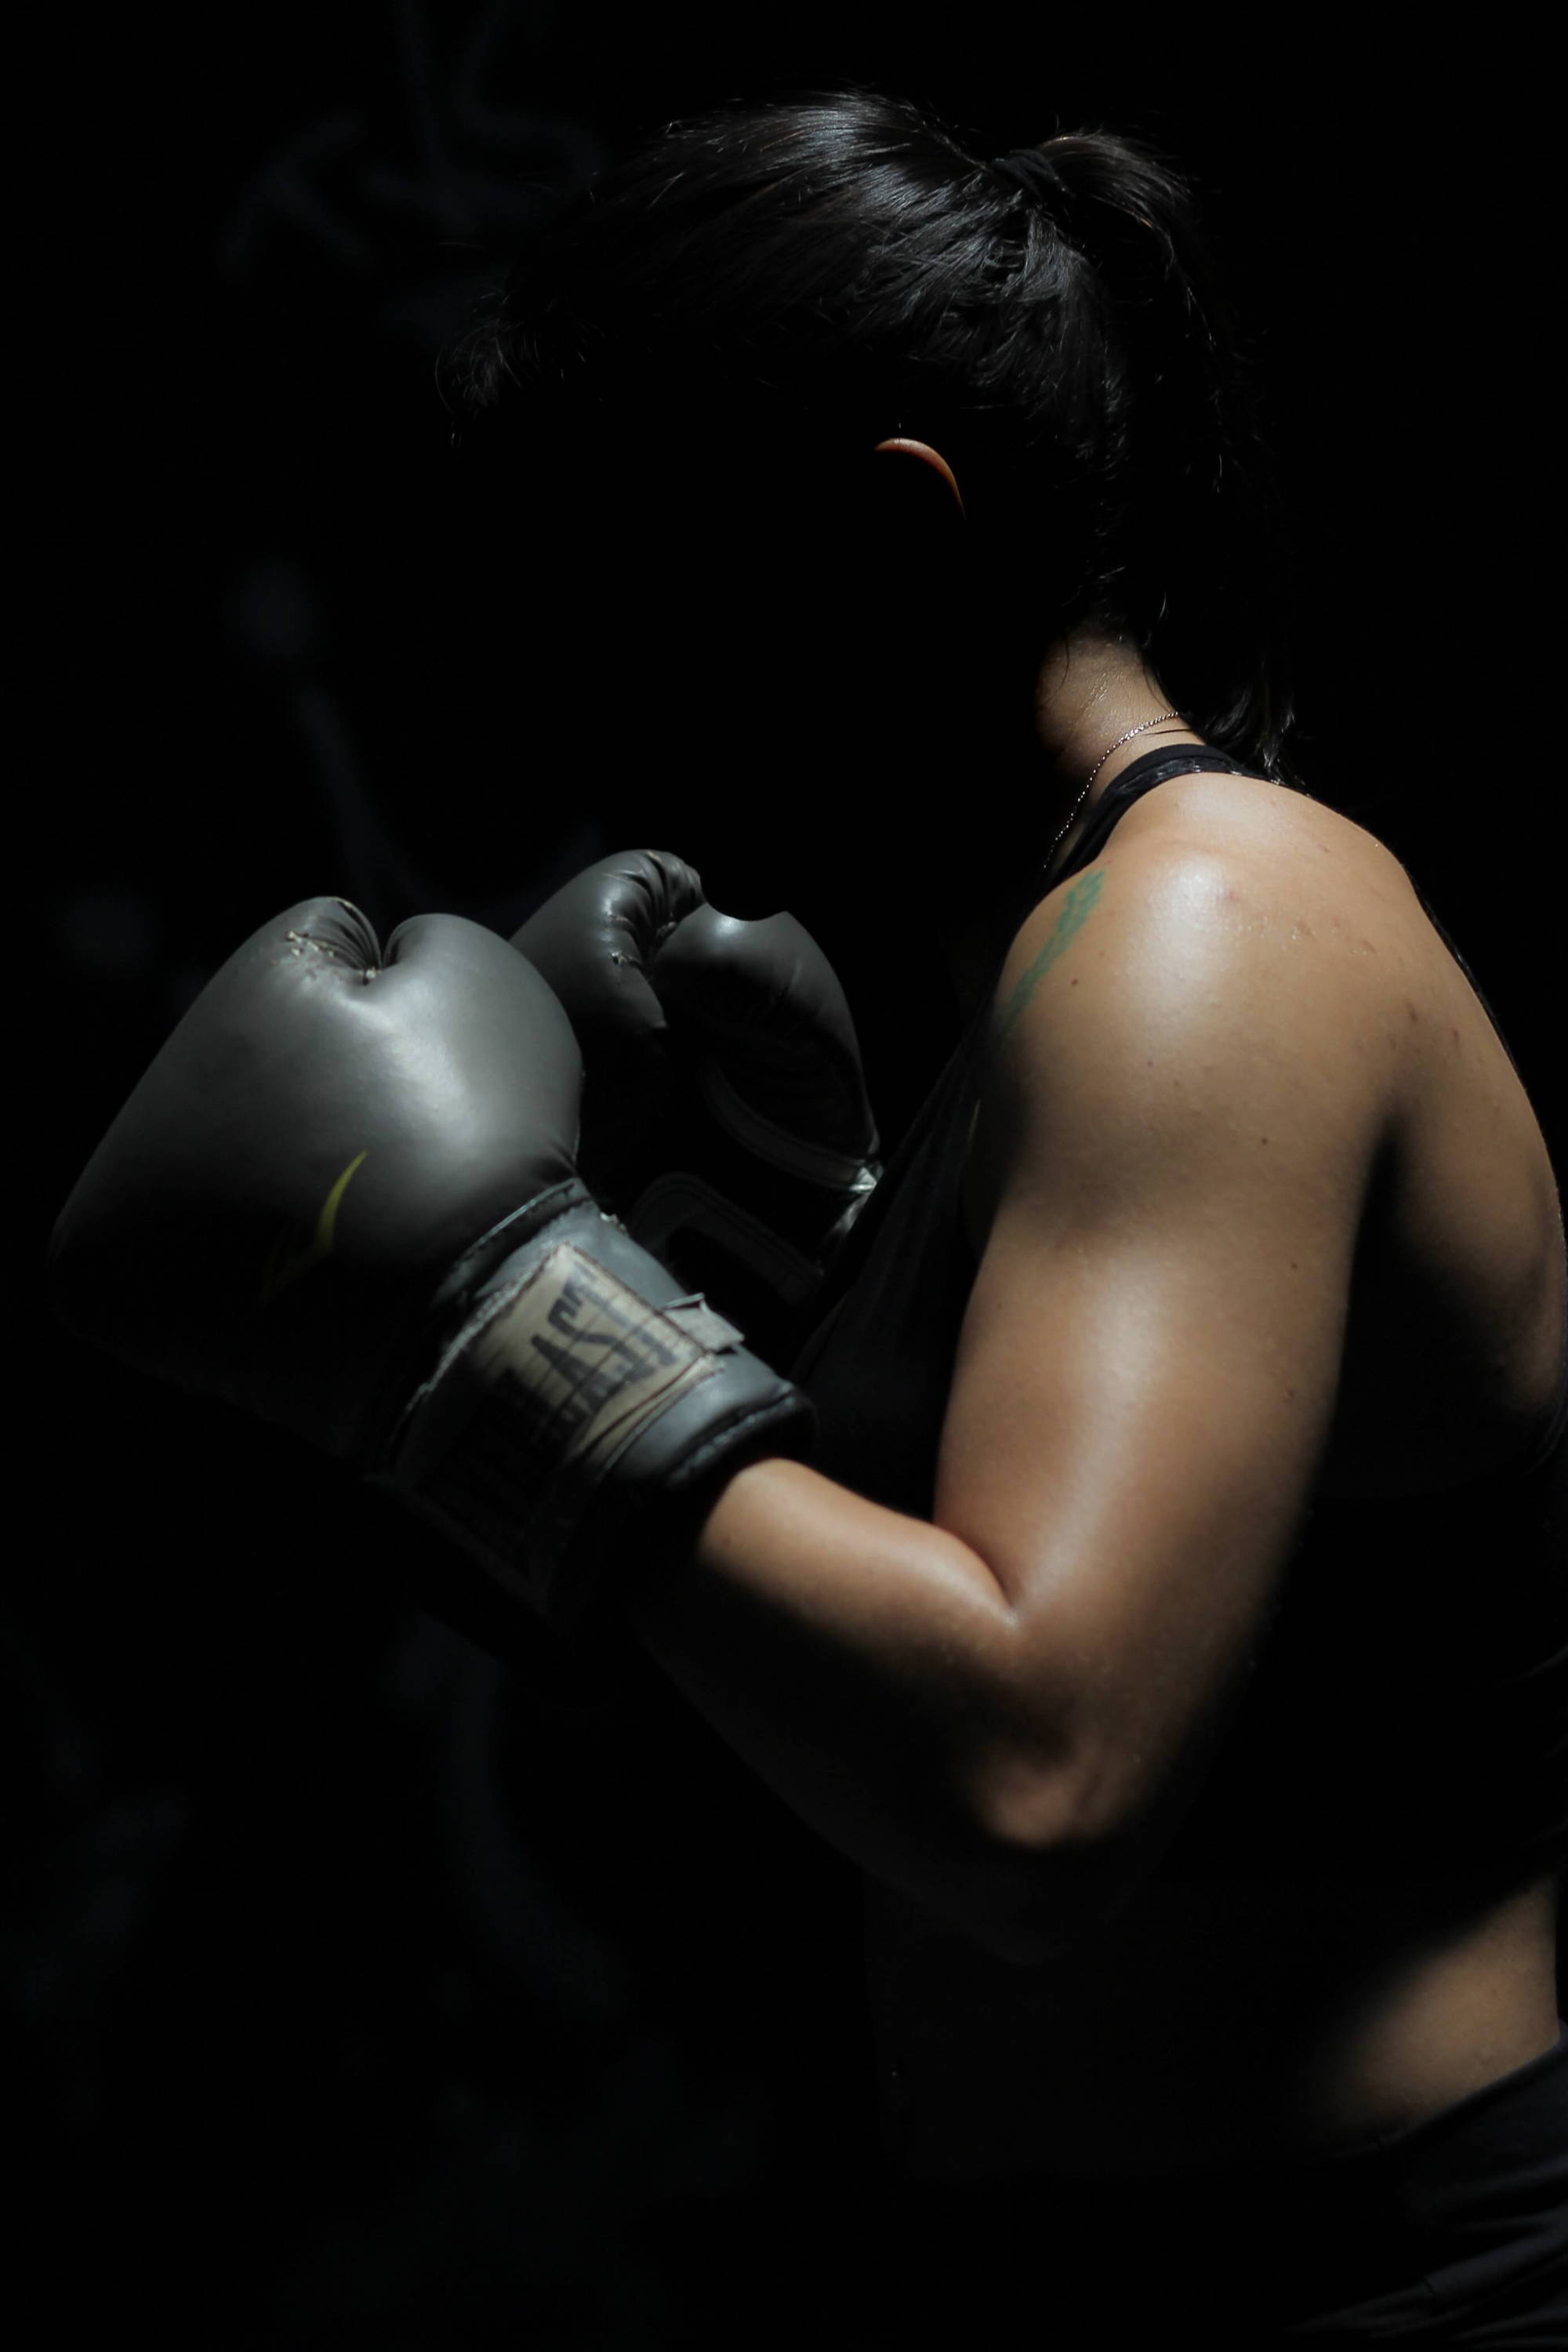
[633,828,1385,1964]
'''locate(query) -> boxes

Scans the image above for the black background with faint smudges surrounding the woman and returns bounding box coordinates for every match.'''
[18,0,1563,2347]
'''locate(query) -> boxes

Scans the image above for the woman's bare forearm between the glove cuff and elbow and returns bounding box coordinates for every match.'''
[623,1458,1081,1959]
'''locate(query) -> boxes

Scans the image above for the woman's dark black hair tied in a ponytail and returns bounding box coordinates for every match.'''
[440,85,1305,790]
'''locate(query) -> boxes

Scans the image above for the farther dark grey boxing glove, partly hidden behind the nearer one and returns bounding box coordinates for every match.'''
[513,849,881,1364]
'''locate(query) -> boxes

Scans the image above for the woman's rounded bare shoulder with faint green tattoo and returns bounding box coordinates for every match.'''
[964,776,1422,1249]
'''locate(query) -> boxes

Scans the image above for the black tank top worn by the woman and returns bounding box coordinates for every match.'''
[792,748,1568,1893]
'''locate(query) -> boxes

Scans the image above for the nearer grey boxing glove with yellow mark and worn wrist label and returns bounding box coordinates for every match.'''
[49,898,813,1675]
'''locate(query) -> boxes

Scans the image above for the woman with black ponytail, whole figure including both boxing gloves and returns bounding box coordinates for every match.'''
[54,89,1568,2347]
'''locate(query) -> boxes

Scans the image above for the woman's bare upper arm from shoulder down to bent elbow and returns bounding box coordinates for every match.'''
[933,851,1387,1929]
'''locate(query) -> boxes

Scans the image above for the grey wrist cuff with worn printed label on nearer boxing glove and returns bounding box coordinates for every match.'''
[374,1181,815,1642]
